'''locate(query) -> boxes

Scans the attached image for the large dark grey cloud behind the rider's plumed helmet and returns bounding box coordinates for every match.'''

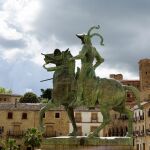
[33,0,150,77]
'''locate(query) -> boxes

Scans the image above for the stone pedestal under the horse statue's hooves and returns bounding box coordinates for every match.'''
[41,137,133,150]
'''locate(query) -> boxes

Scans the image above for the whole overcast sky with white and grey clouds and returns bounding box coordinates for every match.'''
[0,0,150,95]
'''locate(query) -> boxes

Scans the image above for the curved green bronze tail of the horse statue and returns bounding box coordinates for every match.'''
[123,85,142,109]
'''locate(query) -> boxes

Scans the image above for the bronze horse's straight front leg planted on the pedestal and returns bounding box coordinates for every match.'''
[65,106,77,136]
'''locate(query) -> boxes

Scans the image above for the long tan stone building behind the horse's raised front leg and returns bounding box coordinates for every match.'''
[0,103,69,150]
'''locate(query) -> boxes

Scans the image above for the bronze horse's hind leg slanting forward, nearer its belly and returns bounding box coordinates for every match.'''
[88,108,111,137]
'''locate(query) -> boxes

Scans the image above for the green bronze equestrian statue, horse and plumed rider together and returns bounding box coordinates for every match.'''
[40,26,141,137]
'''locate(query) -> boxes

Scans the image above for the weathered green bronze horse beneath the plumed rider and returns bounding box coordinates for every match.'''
[40,49,141,137]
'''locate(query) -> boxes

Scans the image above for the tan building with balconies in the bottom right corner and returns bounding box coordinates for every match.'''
[133,101,150,150]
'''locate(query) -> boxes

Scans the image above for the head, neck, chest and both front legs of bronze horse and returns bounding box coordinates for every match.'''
[40,49,77,136]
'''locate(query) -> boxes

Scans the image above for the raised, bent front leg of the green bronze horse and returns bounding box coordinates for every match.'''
[39,100,55,132]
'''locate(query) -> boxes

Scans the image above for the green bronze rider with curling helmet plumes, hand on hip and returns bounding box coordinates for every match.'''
[74,26,104,104]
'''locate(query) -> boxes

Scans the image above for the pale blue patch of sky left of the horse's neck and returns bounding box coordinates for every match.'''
[0,60,52,95]
